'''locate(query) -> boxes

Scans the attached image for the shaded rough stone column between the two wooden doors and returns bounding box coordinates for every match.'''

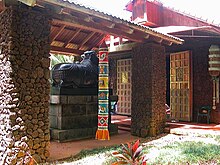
[131,44,166,137]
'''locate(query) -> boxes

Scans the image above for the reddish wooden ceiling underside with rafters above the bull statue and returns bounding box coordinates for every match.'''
[50,20,105,55]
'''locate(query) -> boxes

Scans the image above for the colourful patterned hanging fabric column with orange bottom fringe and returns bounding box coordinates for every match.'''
[96,42,110,140]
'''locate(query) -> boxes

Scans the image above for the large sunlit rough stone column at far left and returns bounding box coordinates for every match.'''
[0,6,50,164]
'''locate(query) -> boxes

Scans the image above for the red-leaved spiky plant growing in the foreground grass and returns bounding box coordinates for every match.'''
[112,140,147,165]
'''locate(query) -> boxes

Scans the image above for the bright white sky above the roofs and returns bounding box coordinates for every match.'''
[71,0,220,24]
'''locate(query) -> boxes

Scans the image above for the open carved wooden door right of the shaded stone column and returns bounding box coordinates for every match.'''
[170,51,192,121]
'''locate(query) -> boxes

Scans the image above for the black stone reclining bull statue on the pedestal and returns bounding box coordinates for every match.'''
[52,51,99,88]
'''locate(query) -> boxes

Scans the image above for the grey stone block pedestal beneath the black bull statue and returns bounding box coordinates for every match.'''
[49,89,118,142]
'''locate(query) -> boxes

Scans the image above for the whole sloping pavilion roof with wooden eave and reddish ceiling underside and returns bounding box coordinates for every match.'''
[0,0,183,55]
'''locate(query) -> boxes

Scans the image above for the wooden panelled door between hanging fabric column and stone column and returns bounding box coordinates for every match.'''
[117,59,132,115]
